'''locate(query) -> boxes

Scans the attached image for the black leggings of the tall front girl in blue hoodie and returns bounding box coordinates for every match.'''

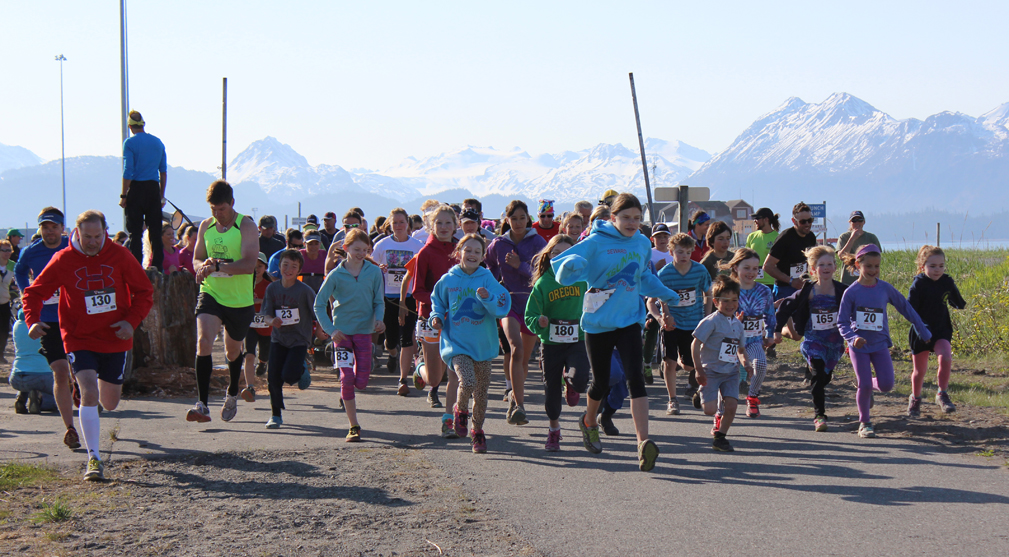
[585,323,648,401]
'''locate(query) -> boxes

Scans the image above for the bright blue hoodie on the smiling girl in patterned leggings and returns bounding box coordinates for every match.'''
[431,265,512,365]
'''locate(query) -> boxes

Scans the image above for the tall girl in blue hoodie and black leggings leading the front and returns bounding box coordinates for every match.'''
[551,194,679,472]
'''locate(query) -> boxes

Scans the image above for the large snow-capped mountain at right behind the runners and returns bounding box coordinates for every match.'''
[683,93,1009,214]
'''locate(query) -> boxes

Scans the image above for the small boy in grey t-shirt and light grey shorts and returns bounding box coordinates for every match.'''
[691,275,753,452]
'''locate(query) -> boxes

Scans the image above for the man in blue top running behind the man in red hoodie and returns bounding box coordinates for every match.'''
[14,207,75,449]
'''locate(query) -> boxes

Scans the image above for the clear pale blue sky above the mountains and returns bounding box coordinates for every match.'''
[0,0,1009,171]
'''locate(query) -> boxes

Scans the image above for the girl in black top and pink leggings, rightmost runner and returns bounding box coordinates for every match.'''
[907,245,967,418]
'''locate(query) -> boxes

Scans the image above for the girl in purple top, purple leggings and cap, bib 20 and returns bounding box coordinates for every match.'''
[837,244,932,438]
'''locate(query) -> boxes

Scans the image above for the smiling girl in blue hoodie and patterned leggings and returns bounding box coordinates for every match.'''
[431,234,512,453]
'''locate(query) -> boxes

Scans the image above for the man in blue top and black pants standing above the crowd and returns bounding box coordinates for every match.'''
[119,110,169,270]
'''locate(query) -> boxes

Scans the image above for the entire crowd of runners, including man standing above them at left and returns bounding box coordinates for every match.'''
[7,112,966,480]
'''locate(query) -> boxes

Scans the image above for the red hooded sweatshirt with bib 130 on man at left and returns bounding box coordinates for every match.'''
[24,229,154,353]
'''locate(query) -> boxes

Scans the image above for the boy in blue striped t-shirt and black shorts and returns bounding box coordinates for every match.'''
[649,232,711,416]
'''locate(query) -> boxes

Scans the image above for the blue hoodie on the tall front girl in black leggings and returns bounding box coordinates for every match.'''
[550,221,679,334]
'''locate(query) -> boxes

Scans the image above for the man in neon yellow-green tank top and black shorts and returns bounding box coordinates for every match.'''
[186,180,259,423]
